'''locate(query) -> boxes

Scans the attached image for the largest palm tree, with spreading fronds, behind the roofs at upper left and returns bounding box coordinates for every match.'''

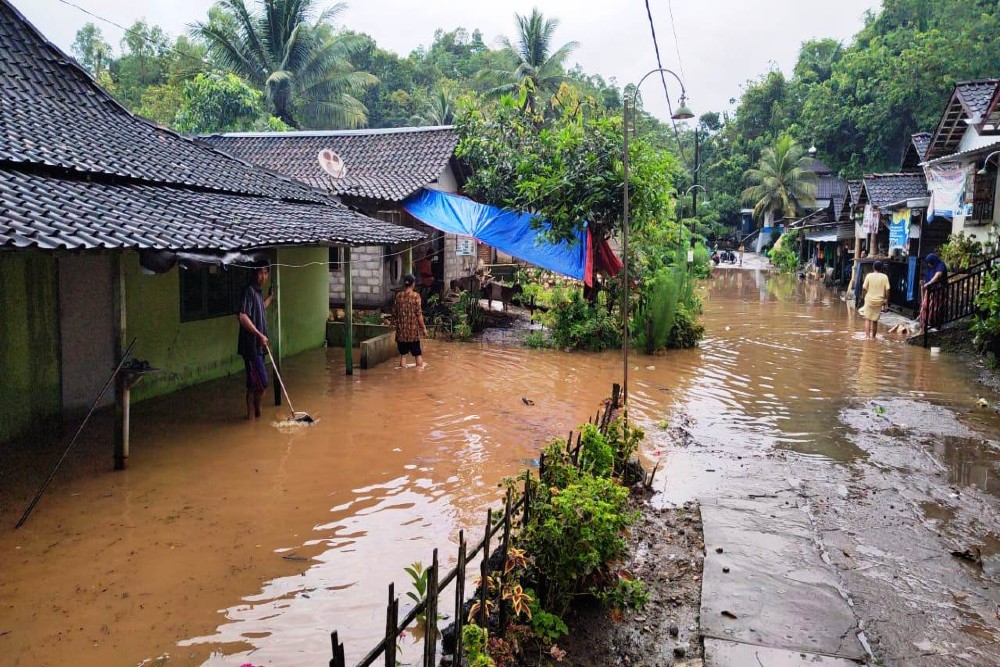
[192,0,378,128]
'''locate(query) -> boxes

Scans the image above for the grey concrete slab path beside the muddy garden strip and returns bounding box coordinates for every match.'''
[701,494,868,667]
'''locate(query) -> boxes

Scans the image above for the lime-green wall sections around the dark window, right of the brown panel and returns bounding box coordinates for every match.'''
[124,248,329,400]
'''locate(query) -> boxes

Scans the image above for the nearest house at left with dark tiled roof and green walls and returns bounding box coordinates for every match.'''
[0,0,423,448]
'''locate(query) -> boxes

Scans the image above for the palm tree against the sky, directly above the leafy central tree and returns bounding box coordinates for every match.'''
[479,9,579,114]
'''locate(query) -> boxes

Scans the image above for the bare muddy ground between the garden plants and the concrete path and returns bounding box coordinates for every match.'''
[558,493,705,667]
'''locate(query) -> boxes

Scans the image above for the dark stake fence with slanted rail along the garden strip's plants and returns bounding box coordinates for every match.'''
[330,384,620,667]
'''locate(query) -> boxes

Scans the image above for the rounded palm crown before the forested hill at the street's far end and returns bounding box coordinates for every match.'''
[742,134,816,227]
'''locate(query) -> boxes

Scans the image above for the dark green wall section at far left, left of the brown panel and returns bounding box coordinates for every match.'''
[0,251,62,442]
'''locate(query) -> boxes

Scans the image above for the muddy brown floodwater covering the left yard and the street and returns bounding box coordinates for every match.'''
[0,271,1000,665]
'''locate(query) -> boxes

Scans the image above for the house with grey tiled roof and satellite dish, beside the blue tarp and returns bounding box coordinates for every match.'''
[203,126,468,306]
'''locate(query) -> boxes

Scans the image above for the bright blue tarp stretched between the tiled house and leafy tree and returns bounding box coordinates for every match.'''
[403,189,587,280]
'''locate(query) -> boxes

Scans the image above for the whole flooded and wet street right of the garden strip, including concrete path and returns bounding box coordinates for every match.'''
[633,272,1000,666]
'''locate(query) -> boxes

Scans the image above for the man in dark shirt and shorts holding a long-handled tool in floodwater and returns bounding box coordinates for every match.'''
[236,263,274,421]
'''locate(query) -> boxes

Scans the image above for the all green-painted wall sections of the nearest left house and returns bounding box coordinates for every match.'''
[0,248,329,443]
